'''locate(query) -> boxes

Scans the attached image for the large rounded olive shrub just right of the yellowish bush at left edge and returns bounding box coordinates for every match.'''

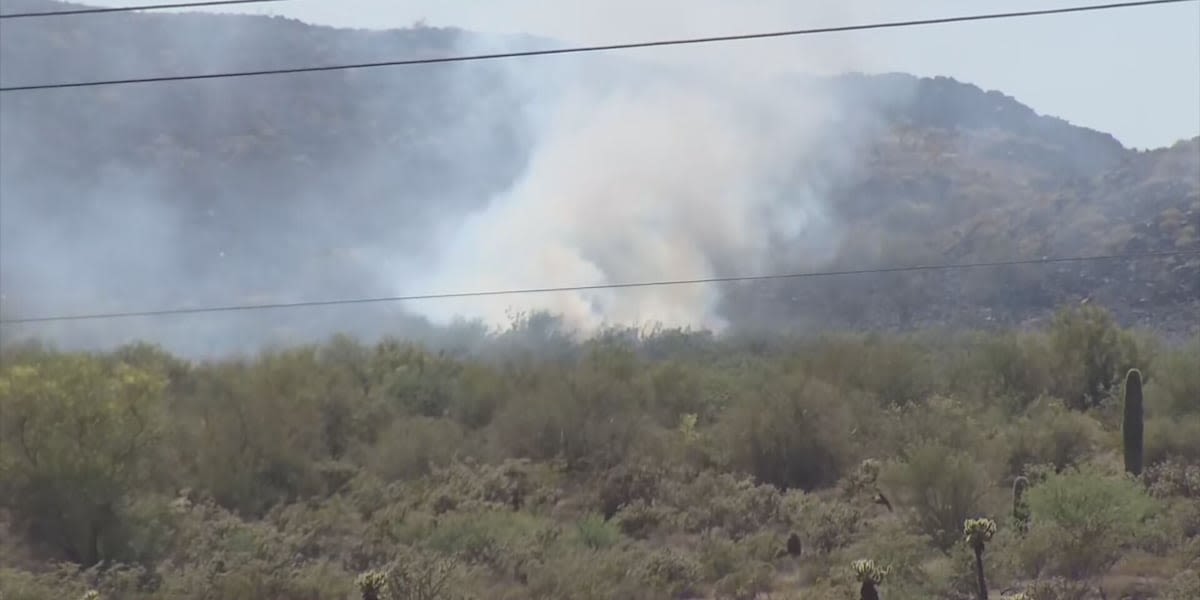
[170,348,353,516]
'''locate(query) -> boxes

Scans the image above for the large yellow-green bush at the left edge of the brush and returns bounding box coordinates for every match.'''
[0,354,167,565]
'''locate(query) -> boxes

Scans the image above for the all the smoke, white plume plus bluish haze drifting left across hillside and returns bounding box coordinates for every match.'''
[0,1,902,355]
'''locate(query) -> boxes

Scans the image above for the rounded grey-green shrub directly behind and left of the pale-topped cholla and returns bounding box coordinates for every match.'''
[883,443,989,550]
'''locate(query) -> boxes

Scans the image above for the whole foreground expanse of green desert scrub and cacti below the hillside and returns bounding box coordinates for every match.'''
[0,306,1200,600]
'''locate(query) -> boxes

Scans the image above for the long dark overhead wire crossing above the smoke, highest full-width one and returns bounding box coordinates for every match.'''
[0,0,1200,92]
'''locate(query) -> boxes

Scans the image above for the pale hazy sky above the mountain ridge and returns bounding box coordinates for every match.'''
[63,0,1200,148]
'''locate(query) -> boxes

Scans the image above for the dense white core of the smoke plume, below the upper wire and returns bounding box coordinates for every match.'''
[404,56,849,331]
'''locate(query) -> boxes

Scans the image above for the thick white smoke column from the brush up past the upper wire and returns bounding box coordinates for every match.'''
[397,10,905,332]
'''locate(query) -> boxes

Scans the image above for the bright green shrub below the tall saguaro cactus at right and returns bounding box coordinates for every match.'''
[1022,470,1157,580]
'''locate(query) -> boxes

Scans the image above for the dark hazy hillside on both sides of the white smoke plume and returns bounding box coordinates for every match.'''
[0,0,1200,348]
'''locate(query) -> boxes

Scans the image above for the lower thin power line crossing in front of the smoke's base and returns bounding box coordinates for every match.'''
[0,248,1200,325]
